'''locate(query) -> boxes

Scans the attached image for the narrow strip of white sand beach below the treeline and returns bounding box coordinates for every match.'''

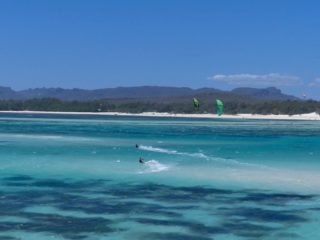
[0,111,320,121]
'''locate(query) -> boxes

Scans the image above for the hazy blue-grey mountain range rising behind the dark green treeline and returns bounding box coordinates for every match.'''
[0,86,299,101]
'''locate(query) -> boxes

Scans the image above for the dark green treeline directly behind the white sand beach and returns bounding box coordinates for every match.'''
[0,98,320,115]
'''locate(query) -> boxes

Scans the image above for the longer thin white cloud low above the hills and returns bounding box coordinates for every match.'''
[209,73,303,86]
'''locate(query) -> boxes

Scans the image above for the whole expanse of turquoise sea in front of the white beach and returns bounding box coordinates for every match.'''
[0,114,320,240]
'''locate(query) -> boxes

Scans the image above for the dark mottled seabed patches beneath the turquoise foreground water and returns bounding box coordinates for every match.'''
[0,175,318,240]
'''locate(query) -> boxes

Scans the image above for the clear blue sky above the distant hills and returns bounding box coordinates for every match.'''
[0,0,320,99]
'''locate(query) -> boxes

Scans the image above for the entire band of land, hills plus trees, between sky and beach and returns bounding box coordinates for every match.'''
[0,86,320,114]
